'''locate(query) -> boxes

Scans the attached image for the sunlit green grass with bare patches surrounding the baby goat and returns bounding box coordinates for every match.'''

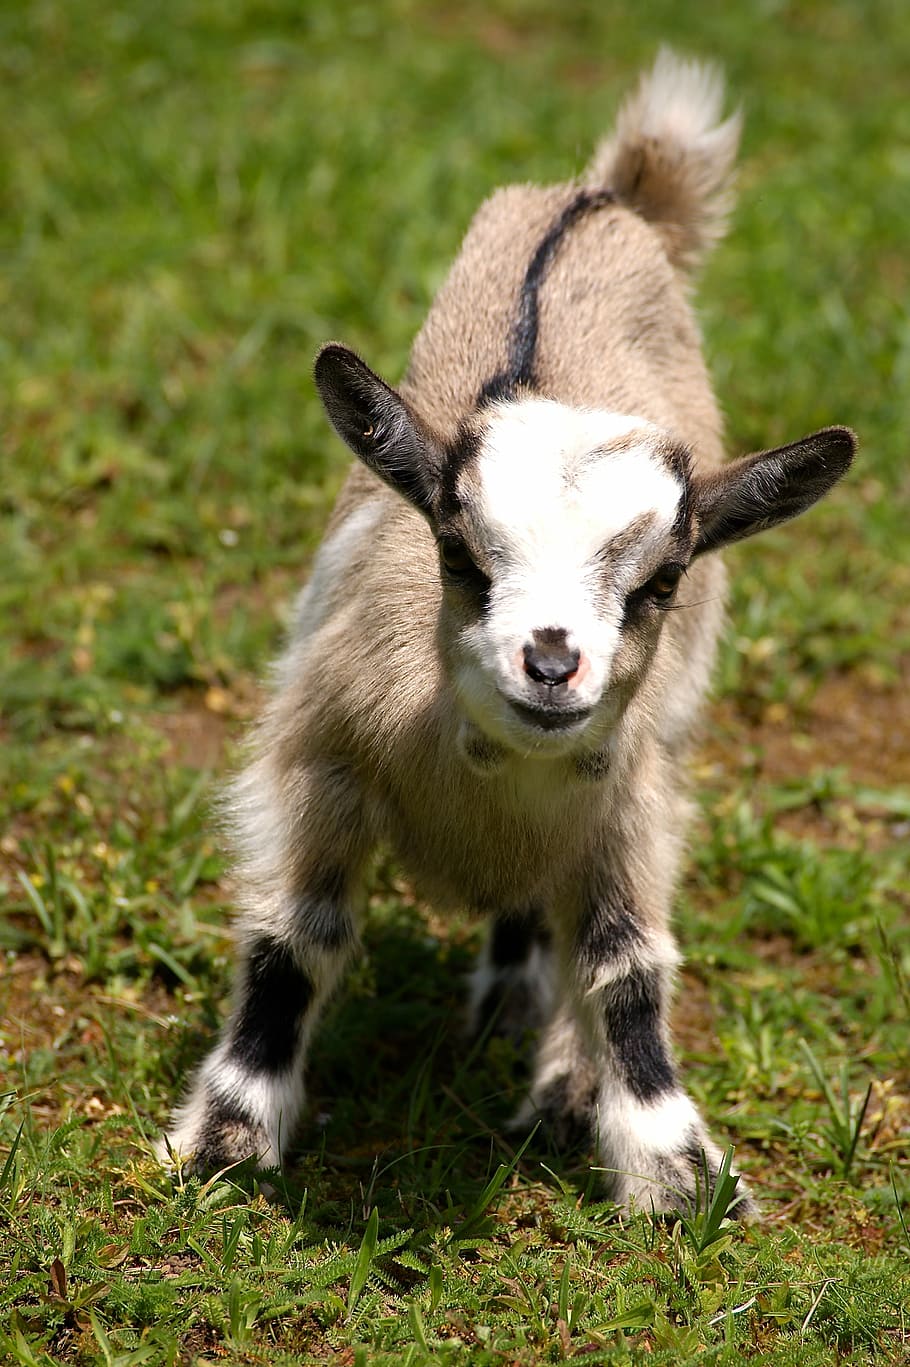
[0,0,910,1367]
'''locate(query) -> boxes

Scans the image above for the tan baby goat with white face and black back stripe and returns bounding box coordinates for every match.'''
[164,52,854,1215]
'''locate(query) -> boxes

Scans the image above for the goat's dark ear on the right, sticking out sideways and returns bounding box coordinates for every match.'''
[693,428,857,555]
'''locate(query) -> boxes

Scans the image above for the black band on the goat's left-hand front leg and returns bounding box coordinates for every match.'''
[231,936,313,1073]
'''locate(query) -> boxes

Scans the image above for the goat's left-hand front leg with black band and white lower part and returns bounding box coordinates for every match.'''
[158,764,363,1172]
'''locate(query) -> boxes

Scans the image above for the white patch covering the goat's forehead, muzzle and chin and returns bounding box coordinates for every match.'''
[456,399,683,755]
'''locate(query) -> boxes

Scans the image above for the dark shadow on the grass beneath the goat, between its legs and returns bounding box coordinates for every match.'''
[170,913,594,1236]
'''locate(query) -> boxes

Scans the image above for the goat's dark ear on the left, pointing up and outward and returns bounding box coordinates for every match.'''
[314,342,439,514]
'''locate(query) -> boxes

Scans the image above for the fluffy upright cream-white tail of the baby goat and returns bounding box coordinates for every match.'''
[585,48,742,269]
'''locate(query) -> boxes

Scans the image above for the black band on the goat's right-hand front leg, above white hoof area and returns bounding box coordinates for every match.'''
[604,968,676,1102]
